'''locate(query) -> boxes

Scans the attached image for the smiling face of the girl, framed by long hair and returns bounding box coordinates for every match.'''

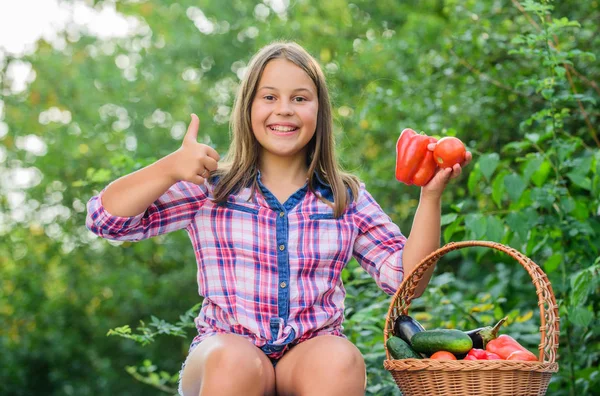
[250,59,319,165]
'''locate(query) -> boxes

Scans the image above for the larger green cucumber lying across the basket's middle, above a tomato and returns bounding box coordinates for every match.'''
[410,329,473,356]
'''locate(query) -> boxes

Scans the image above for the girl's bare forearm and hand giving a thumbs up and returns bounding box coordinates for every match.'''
[102,114,219,217]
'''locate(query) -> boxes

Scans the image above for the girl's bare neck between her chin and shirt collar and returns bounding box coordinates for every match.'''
[259,154,308,186]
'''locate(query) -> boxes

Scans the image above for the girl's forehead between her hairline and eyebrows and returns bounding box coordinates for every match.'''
[258,59,317,92]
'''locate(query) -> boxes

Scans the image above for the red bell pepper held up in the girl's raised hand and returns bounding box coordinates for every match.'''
[396,129,437,187]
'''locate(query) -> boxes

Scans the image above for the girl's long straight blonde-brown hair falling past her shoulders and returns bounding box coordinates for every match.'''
[211,42,359,217]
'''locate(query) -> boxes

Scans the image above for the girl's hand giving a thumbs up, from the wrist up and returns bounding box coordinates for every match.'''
[169,114,220,184]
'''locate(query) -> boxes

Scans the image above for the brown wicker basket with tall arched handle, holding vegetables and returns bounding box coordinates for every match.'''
[383,241,559,396]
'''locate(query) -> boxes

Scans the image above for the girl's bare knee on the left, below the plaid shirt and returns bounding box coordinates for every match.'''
[181,334,275,396]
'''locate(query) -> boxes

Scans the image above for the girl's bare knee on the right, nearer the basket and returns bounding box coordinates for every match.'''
[275,335,366,396]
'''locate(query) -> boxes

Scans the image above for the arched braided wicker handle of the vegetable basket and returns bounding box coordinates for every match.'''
[384,241,559,363]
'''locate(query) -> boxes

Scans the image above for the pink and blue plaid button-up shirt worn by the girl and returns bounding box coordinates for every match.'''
[86,176,406,357]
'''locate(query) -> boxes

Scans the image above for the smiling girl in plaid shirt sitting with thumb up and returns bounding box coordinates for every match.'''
[87,43,471,396]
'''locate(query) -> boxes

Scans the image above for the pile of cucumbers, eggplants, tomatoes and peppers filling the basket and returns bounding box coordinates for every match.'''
[386,315,538,362]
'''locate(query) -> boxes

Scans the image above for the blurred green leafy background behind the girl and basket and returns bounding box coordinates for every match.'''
[0,0,600,396]
